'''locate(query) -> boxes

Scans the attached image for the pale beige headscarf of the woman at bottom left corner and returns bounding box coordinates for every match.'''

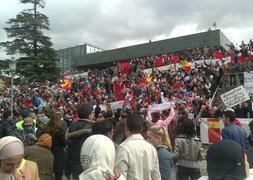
[0,136,24,160]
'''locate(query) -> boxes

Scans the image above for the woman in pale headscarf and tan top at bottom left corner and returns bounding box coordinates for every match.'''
[0,136,40,180]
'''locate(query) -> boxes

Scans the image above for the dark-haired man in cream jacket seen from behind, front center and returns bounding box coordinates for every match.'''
[116,112,161,180]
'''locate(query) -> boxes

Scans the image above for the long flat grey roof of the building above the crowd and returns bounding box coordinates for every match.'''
[72,30,231,67]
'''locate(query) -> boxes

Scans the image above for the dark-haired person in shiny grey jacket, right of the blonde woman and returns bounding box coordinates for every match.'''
[172,119,204,180]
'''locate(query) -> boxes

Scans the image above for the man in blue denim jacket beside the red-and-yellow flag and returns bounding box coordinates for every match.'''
[222,110,248,150]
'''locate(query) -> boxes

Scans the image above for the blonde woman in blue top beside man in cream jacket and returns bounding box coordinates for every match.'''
[147,126,173,180]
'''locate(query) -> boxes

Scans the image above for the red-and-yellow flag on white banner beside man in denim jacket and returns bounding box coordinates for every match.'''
[207,119,221,144]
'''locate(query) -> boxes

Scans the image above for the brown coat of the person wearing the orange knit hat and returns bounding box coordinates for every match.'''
[24,145,54,180]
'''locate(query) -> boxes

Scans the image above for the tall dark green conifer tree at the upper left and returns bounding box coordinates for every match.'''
[0,0,59,81]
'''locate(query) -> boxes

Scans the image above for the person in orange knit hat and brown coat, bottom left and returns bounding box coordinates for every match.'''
[24,134,54,180]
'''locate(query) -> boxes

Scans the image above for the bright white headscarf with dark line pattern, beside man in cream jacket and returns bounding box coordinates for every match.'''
[79,135,115,180]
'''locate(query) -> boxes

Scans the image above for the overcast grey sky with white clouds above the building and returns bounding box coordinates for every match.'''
[0,0,253,59]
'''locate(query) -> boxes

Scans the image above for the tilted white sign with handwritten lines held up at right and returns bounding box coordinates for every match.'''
[220,85,250,107]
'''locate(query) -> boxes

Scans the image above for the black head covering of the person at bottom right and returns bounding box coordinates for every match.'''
[207,140,245,180]
